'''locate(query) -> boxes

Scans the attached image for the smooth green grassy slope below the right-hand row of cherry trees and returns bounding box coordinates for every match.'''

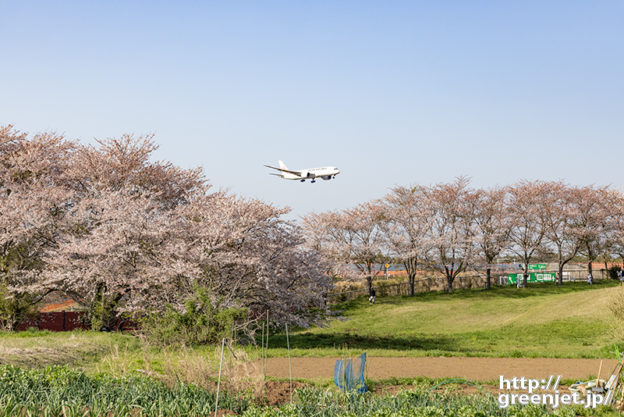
[270,282,624,358]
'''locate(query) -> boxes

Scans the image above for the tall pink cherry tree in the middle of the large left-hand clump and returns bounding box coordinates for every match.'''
[30,135,209,327]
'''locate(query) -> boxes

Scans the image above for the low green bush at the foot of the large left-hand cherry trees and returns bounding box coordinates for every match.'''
[141,287,247,346]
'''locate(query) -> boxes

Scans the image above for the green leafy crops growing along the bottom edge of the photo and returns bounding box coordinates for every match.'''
[0,366,619,417]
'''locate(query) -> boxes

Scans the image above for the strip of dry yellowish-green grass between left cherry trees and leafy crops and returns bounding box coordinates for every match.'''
[0,331,264,392]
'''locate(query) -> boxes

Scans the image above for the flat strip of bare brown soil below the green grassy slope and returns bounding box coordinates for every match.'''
[260,357,616,381]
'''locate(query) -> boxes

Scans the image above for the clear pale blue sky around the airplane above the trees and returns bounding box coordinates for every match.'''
[0,0,624,216]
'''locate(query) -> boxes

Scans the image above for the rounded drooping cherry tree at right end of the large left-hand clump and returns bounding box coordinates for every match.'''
[180,193,331,326]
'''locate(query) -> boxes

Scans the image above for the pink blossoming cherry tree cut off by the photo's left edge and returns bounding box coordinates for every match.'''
[0,126,74,328]
